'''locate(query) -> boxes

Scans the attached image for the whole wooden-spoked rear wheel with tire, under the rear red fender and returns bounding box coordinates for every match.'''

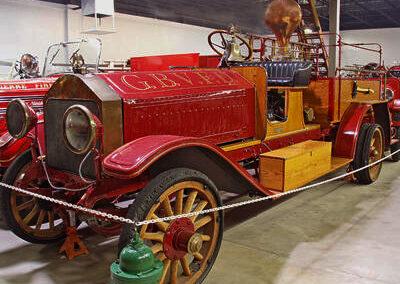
[354,123,384,184]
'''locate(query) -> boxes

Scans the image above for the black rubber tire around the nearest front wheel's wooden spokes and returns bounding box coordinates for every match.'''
[118,168,224,283]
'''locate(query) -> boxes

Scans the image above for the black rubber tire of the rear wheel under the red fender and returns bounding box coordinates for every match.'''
[353,123,385,185]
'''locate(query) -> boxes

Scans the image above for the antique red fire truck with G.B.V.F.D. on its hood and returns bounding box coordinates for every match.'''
[1,0,399,283]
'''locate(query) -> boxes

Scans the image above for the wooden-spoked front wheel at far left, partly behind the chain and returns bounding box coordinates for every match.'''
[1,151,65,243]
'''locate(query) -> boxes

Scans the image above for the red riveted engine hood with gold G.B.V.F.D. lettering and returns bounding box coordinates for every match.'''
[98,69,255,144]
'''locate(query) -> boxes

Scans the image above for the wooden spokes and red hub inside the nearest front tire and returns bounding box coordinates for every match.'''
[140,181,220,283]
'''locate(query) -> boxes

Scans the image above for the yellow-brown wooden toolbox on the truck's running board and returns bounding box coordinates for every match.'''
[260,140,332,191]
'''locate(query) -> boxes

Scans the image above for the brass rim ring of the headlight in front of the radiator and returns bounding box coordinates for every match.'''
[63,105,97,155]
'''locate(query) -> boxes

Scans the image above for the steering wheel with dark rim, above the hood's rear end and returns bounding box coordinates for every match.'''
[208,30,253,60]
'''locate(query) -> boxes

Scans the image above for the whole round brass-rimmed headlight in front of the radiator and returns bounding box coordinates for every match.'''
[63,105,96,154]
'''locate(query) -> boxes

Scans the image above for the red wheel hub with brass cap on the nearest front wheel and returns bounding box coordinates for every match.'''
[163,218,199,260]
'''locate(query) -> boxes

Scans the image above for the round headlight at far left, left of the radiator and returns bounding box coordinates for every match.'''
[6,99,37,139]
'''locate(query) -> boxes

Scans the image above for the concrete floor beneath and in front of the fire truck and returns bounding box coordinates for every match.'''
[0,162,400,284]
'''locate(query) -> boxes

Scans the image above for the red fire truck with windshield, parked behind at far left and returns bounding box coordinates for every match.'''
[0,39,101,172]
